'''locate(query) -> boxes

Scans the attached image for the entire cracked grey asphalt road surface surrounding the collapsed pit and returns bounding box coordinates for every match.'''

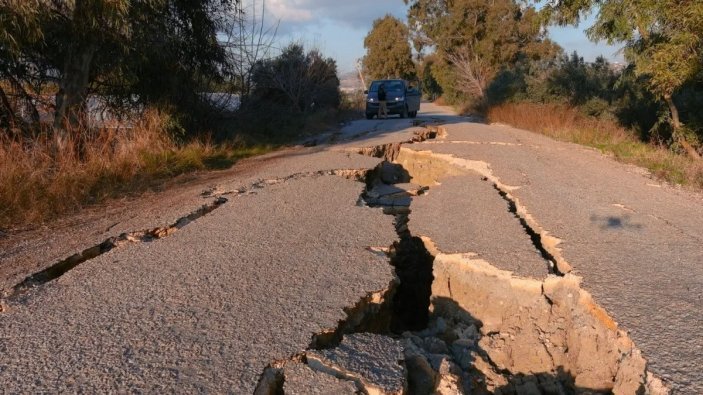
[0,104,703,393]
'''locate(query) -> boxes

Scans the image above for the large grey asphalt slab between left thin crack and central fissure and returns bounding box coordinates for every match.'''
[0,176,396,393]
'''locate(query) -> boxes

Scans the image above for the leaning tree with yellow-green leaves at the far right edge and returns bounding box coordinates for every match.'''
[542,0,703,159]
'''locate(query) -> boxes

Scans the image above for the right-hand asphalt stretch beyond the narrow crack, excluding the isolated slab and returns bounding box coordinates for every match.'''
[409,117,703,393]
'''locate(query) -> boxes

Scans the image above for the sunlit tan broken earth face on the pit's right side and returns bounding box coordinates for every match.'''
[432,254,664,393]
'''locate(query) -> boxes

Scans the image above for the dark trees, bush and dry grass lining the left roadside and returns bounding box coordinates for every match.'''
[0,0,348,231]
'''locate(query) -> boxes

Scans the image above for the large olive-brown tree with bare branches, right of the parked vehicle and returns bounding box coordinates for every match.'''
[405,0,559,101]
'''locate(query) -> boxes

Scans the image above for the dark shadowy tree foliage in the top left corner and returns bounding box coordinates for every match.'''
[0,0,239,135]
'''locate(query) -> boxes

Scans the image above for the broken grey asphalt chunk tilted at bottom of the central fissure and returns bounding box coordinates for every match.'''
[306,333,407,395]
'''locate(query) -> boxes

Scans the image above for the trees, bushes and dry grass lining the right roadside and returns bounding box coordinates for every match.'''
[365,0,703,189]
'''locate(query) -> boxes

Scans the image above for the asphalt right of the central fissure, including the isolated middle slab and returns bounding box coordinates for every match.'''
[332,104,703,394]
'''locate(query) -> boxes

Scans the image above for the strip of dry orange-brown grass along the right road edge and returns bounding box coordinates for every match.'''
[487,103,703,190]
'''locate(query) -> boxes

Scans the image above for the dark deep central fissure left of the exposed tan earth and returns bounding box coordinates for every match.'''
[250,128,439,395]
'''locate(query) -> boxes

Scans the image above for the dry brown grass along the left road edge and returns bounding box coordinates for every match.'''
[0,112,269,228]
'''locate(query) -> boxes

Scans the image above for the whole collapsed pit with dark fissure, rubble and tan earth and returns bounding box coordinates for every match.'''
[252,125,669,394]
